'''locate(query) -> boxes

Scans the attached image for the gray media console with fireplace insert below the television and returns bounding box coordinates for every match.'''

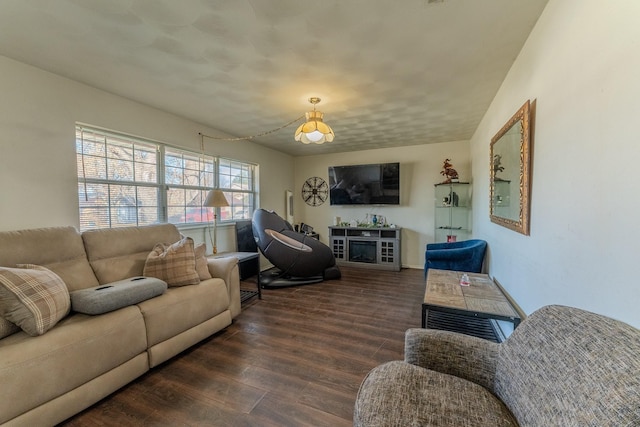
[329,226,401,271]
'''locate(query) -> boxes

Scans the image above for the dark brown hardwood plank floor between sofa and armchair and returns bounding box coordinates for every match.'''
[62,268,424,427]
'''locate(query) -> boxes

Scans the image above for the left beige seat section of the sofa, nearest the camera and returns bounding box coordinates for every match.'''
[0,307,148,425]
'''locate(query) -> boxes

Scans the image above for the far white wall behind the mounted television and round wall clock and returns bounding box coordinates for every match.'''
[291,142,470,268]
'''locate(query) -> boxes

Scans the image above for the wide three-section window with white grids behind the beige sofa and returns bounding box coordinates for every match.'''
[76,125,256,231]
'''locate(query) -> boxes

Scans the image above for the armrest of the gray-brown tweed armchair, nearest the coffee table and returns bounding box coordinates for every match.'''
[404,329,500,391]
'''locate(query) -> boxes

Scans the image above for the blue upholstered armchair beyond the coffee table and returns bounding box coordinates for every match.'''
[424,239,487,277]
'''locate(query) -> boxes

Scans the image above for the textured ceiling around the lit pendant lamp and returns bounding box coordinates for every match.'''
[0,0,547,156]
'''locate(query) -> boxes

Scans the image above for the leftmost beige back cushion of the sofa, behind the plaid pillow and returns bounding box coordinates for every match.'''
[0,227,99,291]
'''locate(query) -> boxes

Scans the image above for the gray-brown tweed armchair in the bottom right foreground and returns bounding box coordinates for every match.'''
[354,306,640,427]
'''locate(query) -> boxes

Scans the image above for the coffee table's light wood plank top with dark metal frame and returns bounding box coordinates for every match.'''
[422,269,521,342]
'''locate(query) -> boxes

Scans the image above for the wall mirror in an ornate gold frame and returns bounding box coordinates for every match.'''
[489,100,531,236]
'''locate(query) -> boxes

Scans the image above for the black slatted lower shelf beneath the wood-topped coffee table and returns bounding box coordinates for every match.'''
[427,310,505,342]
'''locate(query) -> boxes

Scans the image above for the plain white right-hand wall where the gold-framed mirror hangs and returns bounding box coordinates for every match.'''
[471,0,640,327]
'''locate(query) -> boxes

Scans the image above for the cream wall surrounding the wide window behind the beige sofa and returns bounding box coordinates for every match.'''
[0,56,293,250]
